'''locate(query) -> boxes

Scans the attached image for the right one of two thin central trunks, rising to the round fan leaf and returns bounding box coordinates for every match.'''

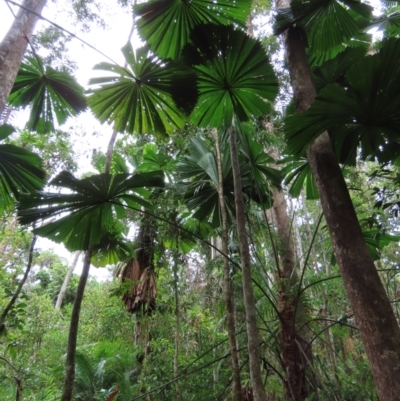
[230,125,267,401]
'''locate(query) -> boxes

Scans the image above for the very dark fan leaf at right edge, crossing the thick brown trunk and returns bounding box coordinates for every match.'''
[285,39,400,163]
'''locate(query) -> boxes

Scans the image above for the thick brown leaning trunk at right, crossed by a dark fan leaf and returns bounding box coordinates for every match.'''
[285,21,400,401]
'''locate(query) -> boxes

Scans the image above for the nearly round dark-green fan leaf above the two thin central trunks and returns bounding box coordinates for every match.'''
[184,25,278,127]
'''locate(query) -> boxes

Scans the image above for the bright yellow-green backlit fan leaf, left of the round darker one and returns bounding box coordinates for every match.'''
[88,43,196,134]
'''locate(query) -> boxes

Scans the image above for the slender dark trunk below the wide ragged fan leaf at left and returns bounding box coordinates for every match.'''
[61,246,92,401]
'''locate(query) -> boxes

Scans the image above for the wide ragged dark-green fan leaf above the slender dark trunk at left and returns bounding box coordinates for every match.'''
[18,171,163,251]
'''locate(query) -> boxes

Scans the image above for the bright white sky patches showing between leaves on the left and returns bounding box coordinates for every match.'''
[0,0,140,279]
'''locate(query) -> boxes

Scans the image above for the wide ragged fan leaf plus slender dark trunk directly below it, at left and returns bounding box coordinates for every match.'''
[18,172,163,401]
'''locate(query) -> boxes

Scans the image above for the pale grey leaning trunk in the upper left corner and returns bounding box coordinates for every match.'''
[0,0,47,114]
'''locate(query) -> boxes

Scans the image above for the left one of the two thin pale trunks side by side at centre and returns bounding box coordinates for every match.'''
[213,129,243,401]
